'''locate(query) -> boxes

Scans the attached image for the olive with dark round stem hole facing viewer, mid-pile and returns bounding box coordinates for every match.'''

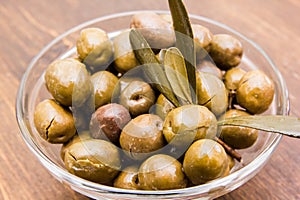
[119,80,155,116]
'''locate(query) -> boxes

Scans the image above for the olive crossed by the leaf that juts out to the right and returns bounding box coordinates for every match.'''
[220,109,258,149]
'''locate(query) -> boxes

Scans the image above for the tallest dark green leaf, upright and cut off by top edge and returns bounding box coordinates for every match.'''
[168,0,197,104]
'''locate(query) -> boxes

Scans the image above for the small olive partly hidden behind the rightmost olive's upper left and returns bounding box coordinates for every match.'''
[224,67,246,92]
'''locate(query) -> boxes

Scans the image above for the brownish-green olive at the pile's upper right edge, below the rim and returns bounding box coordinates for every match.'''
[209,34,243,70]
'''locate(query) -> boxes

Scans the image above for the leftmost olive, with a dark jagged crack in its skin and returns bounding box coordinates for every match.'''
[34,99,76,143]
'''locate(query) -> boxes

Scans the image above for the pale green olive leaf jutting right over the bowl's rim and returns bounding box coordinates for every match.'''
[218,115,300,138]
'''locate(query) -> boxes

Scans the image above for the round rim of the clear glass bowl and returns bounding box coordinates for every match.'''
[16,10,290,196]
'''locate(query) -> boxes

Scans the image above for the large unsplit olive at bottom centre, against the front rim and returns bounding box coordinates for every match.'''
[138,154,187,190]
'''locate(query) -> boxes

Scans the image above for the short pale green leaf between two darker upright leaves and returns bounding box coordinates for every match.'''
[164,47,193,105]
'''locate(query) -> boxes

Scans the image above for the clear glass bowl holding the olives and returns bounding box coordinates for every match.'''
[16,11,289,199]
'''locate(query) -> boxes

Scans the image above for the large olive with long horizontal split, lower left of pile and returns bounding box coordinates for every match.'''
[64,139,121,184]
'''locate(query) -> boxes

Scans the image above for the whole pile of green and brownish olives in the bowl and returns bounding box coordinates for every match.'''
[34,12,274,190]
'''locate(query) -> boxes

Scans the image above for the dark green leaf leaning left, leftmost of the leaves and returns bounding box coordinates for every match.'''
[129,29,180,107]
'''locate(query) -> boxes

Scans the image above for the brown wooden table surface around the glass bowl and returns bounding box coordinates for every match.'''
[0,0,300,200]
